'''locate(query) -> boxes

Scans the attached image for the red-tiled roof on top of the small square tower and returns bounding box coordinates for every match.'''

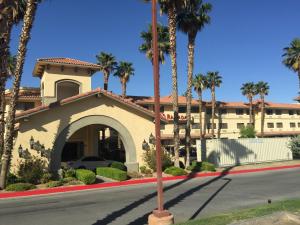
[32,57,100,77]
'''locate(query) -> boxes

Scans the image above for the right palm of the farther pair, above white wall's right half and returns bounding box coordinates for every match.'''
[255,81,270,137]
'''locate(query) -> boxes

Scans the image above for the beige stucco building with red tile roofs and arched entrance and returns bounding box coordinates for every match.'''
[6,58,300,171]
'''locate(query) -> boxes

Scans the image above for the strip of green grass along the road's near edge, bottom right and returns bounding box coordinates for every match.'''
[177,199,300,225]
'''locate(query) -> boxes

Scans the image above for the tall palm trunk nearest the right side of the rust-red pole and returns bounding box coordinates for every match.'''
[168,6,180,167]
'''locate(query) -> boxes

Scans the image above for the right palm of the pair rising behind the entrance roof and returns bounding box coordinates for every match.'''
[114,61,134,98]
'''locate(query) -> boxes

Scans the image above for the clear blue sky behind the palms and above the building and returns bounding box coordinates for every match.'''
[11,0,300,102]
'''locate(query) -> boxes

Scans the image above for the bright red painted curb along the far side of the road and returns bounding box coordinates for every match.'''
[0,164,300,199]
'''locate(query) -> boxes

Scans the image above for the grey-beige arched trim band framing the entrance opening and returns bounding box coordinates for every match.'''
[50,115,138,172]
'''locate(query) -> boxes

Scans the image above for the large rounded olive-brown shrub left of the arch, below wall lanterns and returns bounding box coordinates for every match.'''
[17,157,46,184]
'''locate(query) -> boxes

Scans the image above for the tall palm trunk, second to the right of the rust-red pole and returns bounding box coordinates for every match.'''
[185,35,195,167]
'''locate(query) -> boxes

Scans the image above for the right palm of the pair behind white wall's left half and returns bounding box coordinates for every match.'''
[207,72,222,138]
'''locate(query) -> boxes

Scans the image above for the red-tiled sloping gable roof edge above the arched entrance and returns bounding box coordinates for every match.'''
[16,88,168,123]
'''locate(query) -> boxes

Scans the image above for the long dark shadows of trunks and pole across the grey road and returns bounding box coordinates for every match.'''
[92,167,233,225]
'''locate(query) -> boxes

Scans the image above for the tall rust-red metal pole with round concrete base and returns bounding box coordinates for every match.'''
[148,0,174,225]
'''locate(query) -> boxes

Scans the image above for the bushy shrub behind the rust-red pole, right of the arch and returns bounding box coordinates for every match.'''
[143,148,173,172]
